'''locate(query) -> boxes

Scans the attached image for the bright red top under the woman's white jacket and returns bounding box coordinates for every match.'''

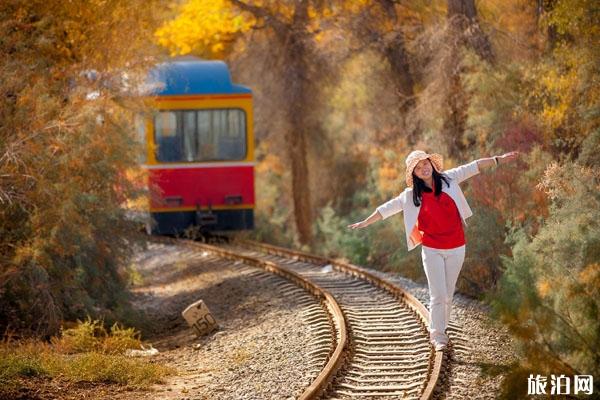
[417,183,466,249]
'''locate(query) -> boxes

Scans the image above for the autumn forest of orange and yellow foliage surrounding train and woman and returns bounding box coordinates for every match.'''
[0,0,600,394]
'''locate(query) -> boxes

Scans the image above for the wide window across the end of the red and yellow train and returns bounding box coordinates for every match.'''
[156,109,246,162]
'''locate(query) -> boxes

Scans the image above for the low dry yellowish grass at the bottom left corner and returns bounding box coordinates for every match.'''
[0,320,174,392]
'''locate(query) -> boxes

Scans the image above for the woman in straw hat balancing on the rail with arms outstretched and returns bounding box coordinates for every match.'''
[348,150,519,351]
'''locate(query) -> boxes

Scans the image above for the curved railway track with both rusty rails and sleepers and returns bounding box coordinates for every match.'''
[162,236,444,399]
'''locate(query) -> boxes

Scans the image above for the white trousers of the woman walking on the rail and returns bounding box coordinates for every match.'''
[421,245,465,343]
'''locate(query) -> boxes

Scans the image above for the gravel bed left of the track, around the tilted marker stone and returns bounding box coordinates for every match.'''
[135,244,326,399]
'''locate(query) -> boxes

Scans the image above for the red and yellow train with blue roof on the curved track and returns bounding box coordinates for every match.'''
[145,58,255,234]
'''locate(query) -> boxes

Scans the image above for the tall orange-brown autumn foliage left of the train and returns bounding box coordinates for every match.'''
[0,0,163,334]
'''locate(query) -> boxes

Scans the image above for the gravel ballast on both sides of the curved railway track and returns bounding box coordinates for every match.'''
[130,244,514,399]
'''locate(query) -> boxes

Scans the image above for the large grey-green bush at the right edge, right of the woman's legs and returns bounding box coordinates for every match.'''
[489,162,600,390]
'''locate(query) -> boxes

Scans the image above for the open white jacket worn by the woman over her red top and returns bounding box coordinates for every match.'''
[377,161,480,251]
